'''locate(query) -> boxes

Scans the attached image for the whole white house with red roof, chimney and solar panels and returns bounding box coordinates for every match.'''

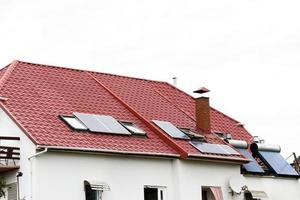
[0,61,300,200]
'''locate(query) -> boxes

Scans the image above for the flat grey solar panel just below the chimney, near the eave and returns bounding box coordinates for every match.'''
[191,142,240,155]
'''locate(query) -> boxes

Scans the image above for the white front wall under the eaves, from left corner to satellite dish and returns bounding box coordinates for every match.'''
[34,152,246,200]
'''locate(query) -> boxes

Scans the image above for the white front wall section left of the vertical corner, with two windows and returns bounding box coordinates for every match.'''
[34,152,175,200]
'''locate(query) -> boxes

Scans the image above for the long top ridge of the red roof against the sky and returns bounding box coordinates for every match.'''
[16,60,167,83]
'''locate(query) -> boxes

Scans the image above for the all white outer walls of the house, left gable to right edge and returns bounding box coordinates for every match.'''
[0,109,300,200]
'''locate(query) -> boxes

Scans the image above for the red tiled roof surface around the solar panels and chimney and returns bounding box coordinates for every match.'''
[0,61,252,161]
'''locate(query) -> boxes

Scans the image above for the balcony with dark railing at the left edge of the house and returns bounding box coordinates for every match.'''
[0,136,20,173]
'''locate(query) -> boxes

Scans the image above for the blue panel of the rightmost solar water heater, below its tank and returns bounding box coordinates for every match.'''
[258,151,299,177]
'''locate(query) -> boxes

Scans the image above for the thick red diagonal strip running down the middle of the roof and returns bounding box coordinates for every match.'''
[87,72,188,158]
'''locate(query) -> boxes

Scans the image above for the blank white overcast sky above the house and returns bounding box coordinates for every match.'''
[0,0,300,157]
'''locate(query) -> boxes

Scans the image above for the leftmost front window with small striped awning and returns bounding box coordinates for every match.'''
[84,181,110,200]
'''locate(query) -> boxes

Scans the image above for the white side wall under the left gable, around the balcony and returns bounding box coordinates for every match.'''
[0,109,35,199]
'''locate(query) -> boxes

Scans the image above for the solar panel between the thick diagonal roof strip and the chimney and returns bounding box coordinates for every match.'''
[152,120,189,139]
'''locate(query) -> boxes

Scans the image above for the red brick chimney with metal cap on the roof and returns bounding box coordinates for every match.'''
[194,87,211,134]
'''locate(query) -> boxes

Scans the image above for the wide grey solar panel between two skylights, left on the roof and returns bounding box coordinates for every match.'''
[74,113,131,135]
